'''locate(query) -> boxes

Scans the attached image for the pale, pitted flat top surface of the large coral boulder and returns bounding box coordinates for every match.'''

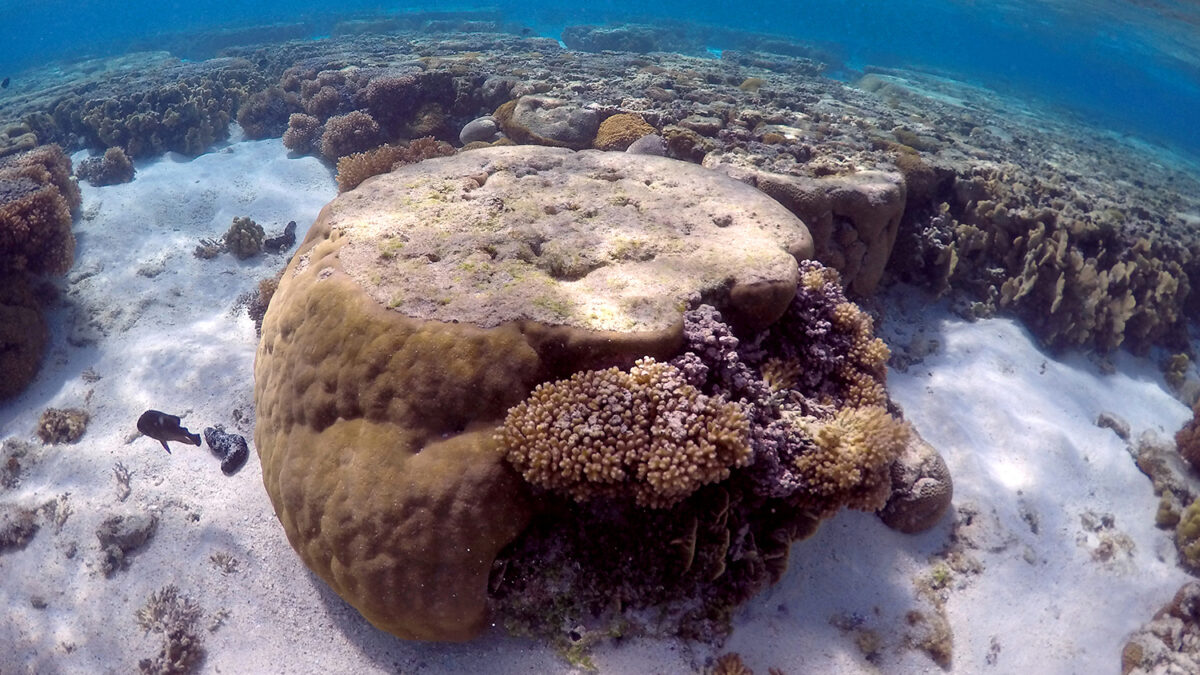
[325,147,812,331]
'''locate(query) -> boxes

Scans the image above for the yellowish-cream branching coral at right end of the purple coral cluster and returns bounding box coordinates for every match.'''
[793,406,912,510]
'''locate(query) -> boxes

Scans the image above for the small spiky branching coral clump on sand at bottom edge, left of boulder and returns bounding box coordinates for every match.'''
[137,584,204,674]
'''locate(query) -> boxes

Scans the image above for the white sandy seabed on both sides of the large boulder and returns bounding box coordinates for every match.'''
[0,132,1189,675]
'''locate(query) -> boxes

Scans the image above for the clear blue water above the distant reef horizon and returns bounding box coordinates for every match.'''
[7,0,1200,156]
